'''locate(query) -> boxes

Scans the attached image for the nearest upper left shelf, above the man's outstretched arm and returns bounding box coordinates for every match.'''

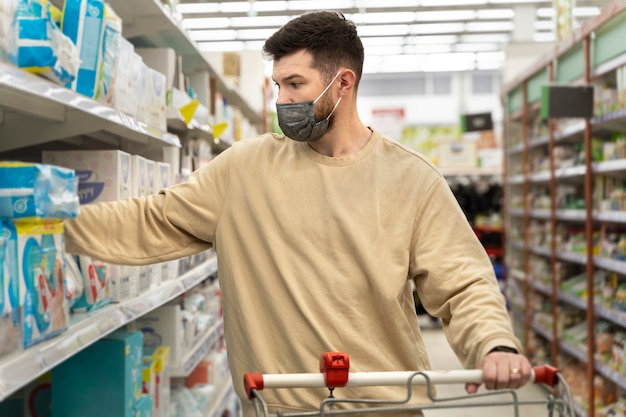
[0,63,181,152]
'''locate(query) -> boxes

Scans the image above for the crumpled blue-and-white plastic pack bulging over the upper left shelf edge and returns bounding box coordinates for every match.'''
[6,0,80,85]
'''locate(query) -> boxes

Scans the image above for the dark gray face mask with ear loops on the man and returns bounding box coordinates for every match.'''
[276,72,341,142]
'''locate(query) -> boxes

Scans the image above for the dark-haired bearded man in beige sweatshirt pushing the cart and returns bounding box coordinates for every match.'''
[66,12,530,416]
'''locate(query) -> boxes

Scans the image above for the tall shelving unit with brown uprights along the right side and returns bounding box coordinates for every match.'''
[503,0,626,416]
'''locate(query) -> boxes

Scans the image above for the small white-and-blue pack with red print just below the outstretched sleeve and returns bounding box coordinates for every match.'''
[72,255,113,311]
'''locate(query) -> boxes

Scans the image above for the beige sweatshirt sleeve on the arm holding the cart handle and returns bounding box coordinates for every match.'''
[411,177,522,368]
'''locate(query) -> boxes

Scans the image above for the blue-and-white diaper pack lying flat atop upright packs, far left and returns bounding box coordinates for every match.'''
[0,162,79,219]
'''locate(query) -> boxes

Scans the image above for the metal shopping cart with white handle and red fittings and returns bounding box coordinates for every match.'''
[244,352,575,417]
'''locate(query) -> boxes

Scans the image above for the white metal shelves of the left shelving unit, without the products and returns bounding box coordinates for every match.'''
[0,0,265,416]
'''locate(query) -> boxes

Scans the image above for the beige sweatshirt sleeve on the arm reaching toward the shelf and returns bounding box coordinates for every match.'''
[64,150,230,265]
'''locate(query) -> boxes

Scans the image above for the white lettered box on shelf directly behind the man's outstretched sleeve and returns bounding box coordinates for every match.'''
[42,150,138,301]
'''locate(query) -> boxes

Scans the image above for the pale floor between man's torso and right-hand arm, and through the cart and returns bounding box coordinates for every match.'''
[420,317,548,417]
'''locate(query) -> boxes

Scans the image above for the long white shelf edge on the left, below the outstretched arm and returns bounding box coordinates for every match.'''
[0,256,217,401]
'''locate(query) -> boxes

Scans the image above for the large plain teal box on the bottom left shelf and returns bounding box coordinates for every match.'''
[51,330,143,417]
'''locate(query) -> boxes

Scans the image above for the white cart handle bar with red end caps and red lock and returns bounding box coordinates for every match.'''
[244,352,559,398]
